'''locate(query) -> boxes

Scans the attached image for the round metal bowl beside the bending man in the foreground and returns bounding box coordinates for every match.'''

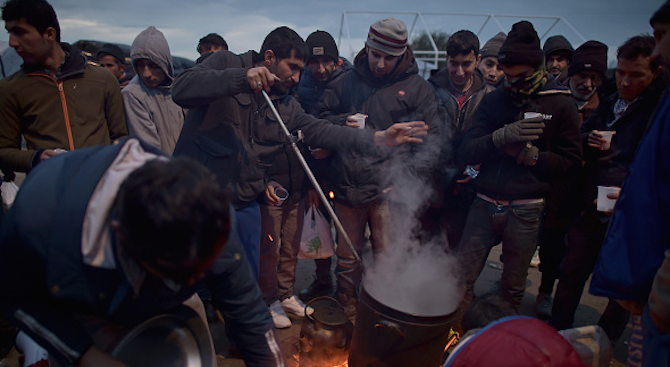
[111,306,216,367]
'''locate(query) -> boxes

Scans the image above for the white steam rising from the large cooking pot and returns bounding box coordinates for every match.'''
[363,114,462,316]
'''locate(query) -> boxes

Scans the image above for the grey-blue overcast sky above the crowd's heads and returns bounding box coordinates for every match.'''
[3,0,663,66]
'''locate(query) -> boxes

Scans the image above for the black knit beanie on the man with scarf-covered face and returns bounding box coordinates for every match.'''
[498,20,544,67]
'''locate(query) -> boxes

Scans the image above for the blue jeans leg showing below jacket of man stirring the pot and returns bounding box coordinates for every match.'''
[235,203,261,281]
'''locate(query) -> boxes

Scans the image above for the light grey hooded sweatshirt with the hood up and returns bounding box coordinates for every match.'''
[123,26,184,155]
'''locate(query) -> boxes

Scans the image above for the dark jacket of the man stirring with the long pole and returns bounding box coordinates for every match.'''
[172,51,374,208]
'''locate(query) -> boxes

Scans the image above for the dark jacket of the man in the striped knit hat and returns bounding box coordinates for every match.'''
[321,48,440,206]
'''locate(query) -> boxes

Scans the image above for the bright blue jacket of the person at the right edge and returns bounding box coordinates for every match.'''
[590,89,670,302]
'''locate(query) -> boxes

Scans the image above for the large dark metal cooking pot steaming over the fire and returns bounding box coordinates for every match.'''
[349,286,459,367]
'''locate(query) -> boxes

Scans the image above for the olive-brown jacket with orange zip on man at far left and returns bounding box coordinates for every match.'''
[0,43,128,172]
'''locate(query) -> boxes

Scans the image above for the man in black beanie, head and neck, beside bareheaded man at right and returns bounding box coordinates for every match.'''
[565,41,607,123]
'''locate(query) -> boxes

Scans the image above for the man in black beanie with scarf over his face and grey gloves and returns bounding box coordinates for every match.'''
[456,21,582,320]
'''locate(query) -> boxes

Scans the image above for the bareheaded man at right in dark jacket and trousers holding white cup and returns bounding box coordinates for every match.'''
[550,36,664,342]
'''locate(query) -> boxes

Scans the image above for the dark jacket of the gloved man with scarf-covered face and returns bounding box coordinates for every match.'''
[456,78,582,200]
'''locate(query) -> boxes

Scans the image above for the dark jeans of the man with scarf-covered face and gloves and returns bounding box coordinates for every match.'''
[456,197,544,310]
